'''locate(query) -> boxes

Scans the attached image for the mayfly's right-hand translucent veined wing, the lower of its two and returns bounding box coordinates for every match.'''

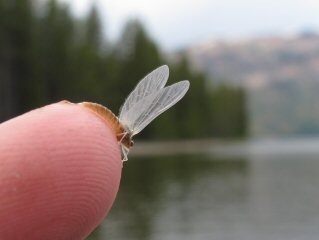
[120,81,189,136]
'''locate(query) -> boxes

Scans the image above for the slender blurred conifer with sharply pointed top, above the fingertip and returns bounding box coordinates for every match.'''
[69,6,108,102]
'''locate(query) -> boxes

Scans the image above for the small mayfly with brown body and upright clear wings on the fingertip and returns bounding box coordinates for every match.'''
[79,65,189,161]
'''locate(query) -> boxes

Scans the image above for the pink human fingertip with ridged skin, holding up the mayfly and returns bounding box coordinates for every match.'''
[0,102,122,240]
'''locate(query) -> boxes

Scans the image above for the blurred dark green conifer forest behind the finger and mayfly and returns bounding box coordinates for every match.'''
[0,0,248,140]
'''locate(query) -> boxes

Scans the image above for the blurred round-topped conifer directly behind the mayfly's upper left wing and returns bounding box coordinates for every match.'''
[113,20,163,114]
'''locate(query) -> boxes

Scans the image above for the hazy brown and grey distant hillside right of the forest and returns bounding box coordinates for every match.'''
[187,34,319,136]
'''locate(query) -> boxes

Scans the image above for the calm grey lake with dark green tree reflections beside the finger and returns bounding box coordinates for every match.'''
[89,139,319,240]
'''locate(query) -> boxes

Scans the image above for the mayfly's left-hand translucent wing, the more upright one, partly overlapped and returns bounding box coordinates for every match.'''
[119,65,169,119]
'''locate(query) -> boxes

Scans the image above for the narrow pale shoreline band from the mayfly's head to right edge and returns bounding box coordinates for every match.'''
[130,137,319,157]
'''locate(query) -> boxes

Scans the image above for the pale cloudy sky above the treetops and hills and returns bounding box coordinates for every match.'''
[60,0,319,50]
